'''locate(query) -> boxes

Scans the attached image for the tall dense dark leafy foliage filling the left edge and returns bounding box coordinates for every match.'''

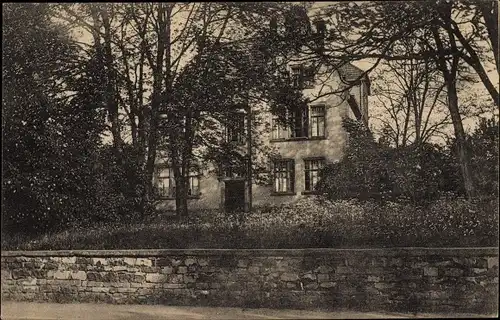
[2,3,103,232]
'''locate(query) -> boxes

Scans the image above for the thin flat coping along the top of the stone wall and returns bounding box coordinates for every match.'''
[1,247,499,257]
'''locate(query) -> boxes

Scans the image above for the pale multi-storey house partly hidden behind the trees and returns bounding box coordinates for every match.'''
[155,59,370,211]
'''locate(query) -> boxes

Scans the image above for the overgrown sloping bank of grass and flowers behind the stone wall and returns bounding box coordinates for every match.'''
[2,198,498,250]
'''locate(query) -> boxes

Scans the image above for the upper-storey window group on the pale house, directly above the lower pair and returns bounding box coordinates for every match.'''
[272,106,326,140]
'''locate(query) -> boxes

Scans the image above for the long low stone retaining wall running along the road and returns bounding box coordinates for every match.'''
[1,248,498,313]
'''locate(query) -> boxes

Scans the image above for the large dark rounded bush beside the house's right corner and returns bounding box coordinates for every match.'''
[317,119,462,203]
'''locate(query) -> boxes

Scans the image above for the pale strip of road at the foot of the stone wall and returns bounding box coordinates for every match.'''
[1,301,494,320]
